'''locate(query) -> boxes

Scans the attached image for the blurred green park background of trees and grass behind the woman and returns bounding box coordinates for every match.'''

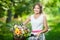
[0,0,60,40]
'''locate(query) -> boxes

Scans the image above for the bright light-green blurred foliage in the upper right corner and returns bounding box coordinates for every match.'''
[41,0,60,16]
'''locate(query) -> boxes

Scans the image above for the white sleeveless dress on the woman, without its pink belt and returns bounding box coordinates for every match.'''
[28,14,45,40]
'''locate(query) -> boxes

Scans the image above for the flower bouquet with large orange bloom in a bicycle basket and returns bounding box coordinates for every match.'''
[13,25,30,40]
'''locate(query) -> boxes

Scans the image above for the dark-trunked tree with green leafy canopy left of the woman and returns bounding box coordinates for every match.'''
[0,0,39,22]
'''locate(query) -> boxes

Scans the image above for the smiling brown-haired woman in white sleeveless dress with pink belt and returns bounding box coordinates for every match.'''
[23,3,48,40]
